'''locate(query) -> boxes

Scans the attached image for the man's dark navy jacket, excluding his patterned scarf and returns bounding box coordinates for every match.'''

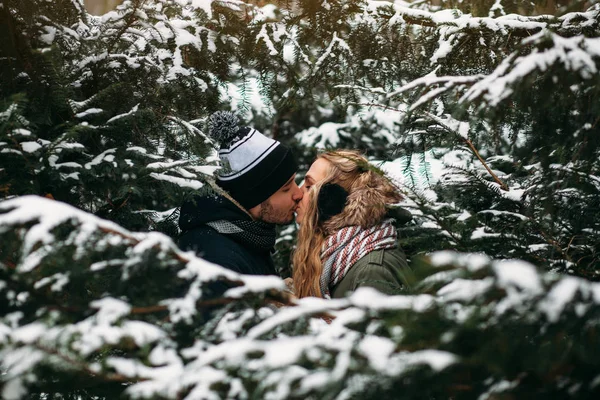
[179,194,277,275]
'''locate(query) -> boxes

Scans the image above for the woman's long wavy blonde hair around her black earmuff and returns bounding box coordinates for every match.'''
[292,150,402,298]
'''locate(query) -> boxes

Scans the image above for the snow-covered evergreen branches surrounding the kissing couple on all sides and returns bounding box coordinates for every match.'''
[0,0,600,399]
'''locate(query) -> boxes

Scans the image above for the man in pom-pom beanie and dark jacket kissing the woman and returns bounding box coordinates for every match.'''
[179,111,303,275]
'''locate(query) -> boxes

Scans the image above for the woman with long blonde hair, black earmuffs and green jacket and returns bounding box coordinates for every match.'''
[293,150,410,298]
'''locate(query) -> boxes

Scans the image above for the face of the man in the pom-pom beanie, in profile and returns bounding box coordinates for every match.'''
[248,174,303,225]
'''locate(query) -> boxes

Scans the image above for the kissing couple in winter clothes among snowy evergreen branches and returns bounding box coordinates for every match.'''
[179,111,411,298]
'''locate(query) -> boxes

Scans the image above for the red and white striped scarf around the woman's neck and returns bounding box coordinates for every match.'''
[319,219,398,298]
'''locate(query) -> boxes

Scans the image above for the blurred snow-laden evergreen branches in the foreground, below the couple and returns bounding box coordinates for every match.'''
[0,197,600,399]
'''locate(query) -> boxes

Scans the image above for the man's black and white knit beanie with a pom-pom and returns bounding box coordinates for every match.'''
[208,111,298,209]
